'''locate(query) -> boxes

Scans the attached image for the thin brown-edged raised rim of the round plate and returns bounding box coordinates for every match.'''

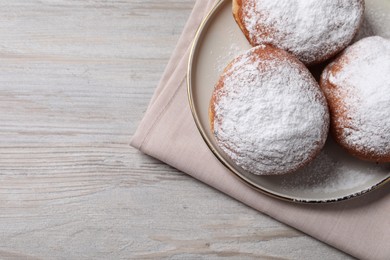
[186,0,390,204]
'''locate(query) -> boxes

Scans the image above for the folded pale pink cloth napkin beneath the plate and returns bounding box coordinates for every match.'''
[131,0,390,259]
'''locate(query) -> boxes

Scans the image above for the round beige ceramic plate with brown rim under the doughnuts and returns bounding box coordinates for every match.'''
[188,0,390,203]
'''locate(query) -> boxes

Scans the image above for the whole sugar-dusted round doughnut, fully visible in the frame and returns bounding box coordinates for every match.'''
[209,45,329,175]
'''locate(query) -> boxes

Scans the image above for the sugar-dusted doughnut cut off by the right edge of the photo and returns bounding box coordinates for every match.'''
[320,36,390,162]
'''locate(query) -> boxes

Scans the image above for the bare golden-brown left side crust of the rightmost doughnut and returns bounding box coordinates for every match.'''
[320,57,390,163]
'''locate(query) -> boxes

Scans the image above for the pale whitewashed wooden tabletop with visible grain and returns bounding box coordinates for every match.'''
[0,0,350,259]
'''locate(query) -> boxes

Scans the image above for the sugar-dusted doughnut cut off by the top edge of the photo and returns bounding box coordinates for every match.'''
[233,0,364,65]
